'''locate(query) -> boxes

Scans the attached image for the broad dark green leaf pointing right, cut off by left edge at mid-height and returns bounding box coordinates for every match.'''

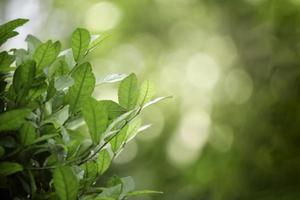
[0,109,31,131]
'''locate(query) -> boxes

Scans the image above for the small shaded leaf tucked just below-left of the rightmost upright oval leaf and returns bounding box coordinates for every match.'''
[98,100,126,120]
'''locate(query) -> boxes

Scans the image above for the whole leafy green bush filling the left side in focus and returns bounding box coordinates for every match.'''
[0,19,165,200]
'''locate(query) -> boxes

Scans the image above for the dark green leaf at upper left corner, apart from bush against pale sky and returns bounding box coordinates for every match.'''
[0,19,28,46]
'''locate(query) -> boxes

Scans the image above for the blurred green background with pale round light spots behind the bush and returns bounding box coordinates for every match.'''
[0,0,300,200]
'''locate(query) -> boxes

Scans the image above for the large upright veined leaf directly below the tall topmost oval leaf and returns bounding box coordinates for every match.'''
[67,63,95,113]
